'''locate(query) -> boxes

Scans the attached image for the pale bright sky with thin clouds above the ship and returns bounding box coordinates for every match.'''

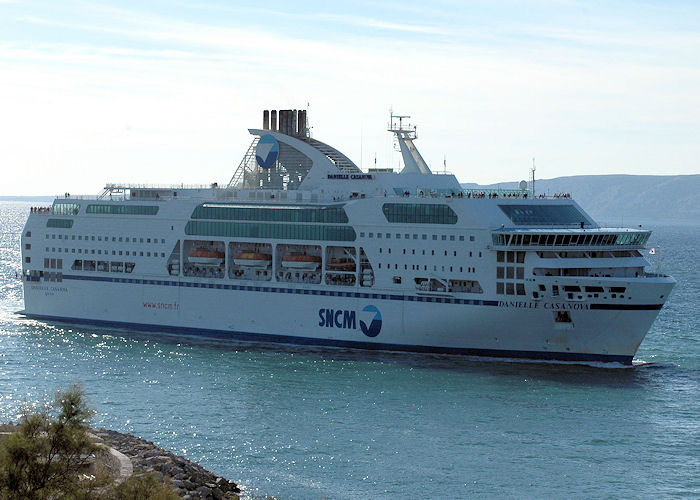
[0,0,700,196]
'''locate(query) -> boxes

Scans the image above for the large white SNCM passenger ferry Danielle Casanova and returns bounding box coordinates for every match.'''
[22,110,675,364]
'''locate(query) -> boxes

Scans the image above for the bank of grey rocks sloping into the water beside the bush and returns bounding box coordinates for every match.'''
[92,429,241,500]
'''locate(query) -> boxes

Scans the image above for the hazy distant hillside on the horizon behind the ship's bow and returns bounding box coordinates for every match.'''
[463,175,700,223]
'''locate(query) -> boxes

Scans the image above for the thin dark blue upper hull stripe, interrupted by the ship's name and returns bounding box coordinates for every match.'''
[47,274,663,311]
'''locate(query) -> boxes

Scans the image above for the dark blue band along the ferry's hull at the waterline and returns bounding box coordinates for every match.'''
[23,313,632,364]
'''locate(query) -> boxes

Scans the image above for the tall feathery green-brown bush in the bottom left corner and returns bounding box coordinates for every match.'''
[0,385,99,500]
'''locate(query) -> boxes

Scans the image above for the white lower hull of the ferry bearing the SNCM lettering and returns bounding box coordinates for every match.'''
[25,277,672,363]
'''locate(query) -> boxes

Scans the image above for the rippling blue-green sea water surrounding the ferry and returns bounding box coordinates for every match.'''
[0,202,700,499]
